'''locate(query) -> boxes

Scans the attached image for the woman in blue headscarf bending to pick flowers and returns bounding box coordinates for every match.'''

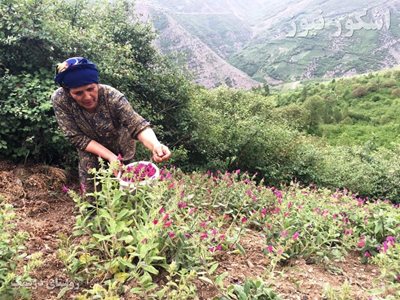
[52,57,171,191]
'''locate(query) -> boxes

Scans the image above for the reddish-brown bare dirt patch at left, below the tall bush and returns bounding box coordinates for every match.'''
[0,162,75,300]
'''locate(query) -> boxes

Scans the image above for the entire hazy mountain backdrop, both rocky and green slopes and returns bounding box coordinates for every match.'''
[134,0,400,88]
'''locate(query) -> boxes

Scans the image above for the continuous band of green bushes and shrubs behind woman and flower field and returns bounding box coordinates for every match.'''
[0,0,400,202]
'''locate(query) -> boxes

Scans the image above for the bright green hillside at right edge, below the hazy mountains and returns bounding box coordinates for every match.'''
[274,68,400,148]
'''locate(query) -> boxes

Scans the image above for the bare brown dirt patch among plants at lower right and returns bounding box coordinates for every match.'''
[208,230,380,300]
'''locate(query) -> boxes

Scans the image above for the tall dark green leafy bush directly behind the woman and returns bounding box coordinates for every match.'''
[0,0,191,162]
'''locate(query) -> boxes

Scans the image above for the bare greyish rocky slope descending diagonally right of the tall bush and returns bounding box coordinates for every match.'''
[136,1,260,89]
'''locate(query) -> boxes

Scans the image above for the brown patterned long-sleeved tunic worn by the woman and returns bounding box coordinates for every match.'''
[51,84,150,185]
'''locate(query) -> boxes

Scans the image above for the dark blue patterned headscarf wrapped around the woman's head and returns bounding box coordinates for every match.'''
[54,57,99,88]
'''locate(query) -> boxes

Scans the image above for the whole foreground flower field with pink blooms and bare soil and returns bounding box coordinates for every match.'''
[0,162,400,300]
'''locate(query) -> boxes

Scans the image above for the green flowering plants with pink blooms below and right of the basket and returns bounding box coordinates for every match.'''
[58,165,400,300]
